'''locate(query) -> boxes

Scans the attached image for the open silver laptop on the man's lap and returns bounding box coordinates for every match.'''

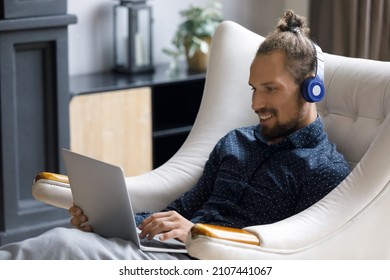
[62,149,187,253]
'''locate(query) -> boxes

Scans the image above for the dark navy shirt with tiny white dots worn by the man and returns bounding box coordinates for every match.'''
[136,117,350,228]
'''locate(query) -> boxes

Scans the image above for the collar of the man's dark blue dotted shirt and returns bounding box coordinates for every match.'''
[256,116,325,148]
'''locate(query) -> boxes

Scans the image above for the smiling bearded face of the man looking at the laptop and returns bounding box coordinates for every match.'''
[249,50,313,144]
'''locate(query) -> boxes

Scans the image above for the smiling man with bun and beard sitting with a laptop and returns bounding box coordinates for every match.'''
[0,11,350,259]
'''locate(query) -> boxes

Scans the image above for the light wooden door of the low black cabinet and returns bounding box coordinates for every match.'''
[69,87,152,176]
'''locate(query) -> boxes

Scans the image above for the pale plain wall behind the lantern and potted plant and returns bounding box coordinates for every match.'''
[68,0,309,75]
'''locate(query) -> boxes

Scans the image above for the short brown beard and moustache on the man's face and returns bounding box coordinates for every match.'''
[260,96,304,142]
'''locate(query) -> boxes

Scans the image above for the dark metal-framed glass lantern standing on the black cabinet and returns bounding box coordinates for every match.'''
[114,0,153,73]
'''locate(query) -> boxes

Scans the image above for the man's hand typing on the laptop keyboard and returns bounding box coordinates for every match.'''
[139,211,194,242]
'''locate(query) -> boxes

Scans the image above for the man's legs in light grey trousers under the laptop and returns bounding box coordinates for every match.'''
[0,228,190,260]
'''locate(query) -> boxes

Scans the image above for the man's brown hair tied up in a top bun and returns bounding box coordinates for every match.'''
[256,10,316,85]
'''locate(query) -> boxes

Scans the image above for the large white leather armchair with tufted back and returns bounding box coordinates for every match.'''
[33,21,390,259]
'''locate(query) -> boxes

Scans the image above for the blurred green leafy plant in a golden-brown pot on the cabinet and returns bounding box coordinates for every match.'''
[163,2,223,71]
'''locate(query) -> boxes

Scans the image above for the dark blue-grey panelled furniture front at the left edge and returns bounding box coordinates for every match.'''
[0,6,76,244]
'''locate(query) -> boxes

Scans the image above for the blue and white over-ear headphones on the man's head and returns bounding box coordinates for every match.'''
[301,43,325,103]
